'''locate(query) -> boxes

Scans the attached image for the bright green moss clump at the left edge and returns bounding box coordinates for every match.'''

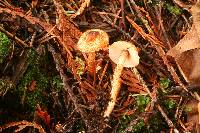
[0,32,11,63]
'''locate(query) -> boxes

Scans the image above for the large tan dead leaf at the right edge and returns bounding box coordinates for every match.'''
[167,1,200,83]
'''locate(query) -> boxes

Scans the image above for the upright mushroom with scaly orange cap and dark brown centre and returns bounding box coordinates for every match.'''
[77,29,109,76]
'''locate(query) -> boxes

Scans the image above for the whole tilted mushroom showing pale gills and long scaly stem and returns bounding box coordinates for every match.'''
[104,41,140,117]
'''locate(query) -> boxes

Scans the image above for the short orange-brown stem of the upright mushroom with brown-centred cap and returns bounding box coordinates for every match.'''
[87,52,96,77]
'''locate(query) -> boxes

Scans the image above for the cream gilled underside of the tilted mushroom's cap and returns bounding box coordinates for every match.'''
[109,41,140,67]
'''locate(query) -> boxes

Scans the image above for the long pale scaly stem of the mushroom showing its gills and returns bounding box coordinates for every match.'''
[104,50,128,117]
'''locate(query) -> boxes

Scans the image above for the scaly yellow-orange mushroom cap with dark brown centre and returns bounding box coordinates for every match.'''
[77,29,109,53]
